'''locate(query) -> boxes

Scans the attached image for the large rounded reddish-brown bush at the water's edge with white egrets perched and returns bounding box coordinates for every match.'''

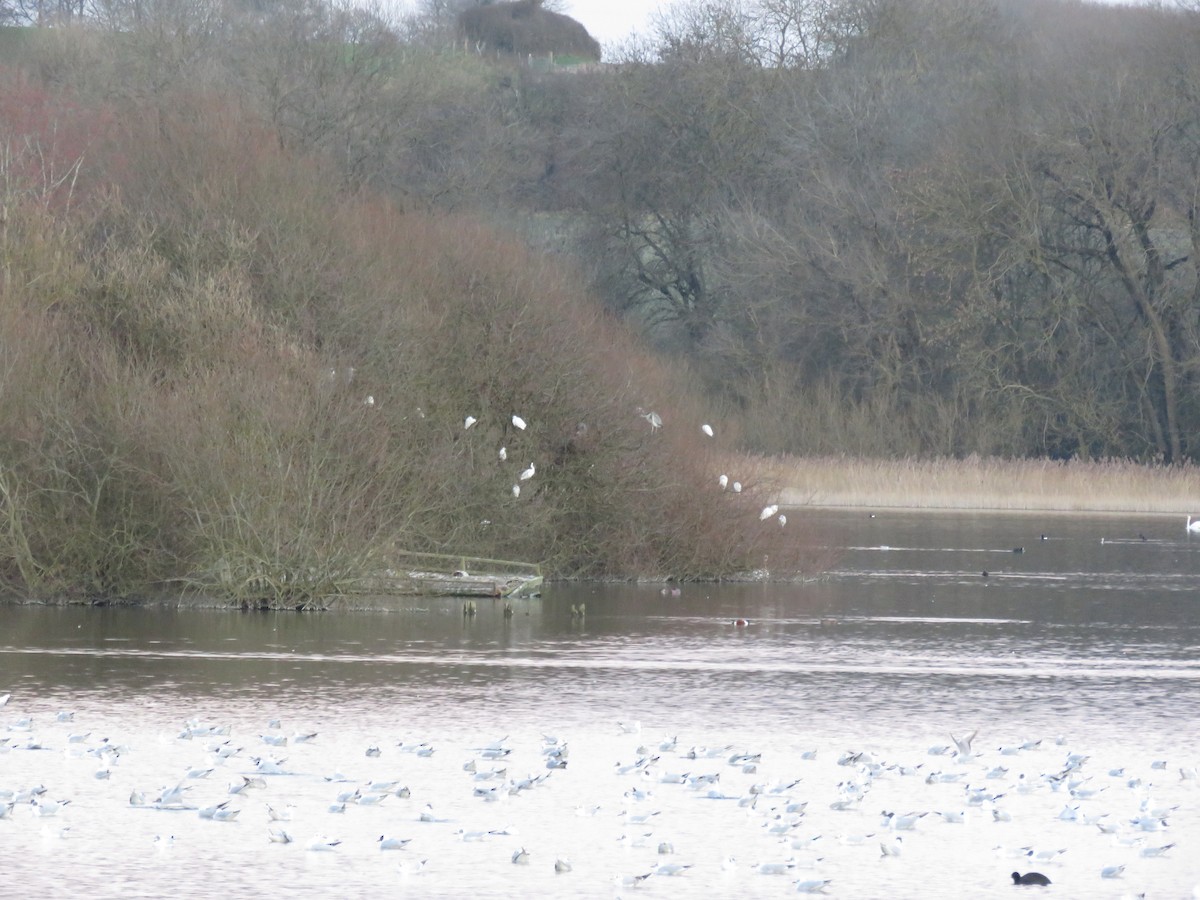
[0,88,814,607]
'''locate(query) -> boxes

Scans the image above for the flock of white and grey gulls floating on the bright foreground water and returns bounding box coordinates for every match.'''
[0,695,1200,896]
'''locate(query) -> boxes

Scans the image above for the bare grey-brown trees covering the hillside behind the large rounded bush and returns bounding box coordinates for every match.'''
[7,0,1200,463]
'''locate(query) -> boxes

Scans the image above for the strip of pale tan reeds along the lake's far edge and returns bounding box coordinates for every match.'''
[764,457,1200,515]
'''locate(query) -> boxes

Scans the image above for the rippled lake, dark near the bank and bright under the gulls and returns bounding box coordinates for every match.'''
[0,510,1200,899]
